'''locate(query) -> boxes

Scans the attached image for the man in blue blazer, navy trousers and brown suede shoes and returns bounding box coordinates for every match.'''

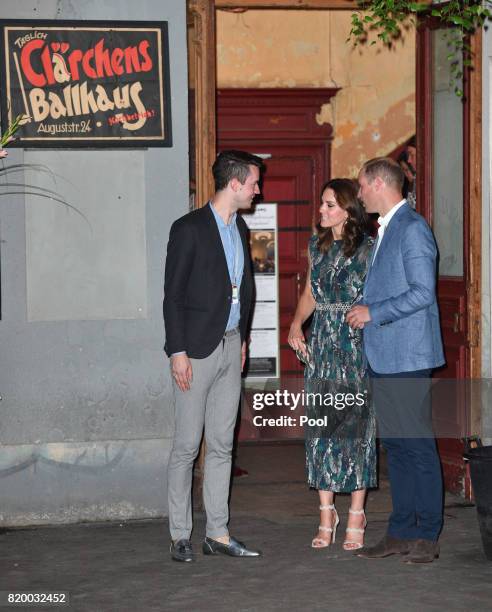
[347,158,444,563]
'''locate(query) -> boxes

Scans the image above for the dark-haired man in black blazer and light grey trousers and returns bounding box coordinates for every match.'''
[164,151,262,561]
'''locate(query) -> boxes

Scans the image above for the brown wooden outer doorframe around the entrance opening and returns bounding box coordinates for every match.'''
[188,0,482,402]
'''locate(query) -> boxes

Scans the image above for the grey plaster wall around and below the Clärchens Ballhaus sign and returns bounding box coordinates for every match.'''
[0,0,188,525]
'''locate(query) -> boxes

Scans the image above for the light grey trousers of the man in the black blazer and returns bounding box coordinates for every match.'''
[168,331,241,540]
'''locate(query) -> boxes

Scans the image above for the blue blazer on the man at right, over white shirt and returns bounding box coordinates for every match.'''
[363,203,444,374]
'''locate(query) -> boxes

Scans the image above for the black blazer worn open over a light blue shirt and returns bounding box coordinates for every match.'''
[164,204,253,359]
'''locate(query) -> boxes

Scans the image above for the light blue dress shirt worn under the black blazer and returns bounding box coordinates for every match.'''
[209,202,244,331]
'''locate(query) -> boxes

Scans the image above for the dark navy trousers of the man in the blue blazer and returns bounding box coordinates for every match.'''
[369,367,443,541]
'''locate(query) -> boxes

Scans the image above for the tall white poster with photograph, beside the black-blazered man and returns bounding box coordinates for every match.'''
[243,203,280,379]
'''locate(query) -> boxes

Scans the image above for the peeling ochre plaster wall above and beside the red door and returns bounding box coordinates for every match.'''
[217,10,415,176]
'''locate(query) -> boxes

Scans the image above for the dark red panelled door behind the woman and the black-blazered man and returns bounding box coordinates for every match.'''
[217,89,337,440]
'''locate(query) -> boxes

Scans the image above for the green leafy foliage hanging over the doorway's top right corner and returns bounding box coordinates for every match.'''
[349,0,492,97]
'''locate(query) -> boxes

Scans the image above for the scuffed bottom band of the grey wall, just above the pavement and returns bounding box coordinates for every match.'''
[0,439,170,526]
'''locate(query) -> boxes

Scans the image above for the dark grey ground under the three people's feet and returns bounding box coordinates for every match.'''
[0,444,492,612]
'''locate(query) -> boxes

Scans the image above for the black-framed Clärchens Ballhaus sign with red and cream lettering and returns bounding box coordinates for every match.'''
[0,20,172,147]
